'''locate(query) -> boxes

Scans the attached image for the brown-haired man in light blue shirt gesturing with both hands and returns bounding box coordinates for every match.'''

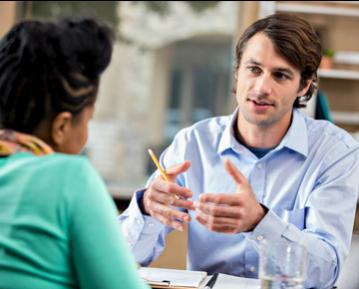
[120,14,359,288]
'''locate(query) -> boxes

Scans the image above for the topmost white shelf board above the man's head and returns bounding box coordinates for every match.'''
[276,1,359,17]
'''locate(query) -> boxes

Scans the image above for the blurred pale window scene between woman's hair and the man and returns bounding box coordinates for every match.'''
[0,1,240,201]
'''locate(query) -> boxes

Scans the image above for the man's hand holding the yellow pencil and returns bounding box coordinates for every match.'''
[142,161,194,231]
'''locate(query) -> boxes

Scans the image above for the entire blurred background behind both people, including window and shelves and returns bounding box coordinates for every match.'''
[0,1,359,282]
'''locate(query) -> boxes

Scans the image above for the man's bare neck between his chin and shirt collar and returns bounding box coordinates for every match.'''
[234,112,292,148]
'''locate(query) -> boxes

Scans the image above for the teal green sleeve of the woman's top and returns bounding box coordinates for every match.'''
[68,162,148,289]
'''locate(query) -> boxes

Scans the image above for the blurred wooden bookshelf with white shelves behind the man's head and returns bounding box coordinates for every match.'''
[259,1,359,132]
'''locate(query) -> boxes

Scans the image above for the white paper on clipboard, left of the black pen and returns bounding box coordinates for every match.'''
[139,267,207,289]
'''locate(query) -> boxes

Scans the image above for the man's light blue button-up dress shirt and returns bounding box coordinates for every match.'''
[120,110,359,288]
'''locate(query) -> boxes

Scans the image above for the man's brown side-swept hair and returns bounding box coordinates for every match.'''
[235,14,322,107]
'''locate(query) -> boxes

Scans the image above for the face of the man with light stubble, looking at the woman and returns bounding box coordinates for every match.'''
[236,33,308,128]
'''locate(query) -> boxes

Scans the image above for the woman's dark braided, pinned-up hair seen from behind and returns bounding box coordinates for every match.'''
[0,18,113,133]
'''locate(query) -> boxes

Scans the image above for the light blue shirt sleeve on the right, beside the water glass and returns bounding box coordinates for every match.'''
[251,150,359,288]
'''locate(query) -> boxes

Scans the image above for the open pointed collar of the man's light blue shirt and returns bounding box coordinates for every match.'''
[218,108,308,157]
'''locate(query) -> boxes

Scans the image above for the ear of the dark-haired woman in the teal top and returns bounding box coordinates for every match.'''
[51,111,72,146]
